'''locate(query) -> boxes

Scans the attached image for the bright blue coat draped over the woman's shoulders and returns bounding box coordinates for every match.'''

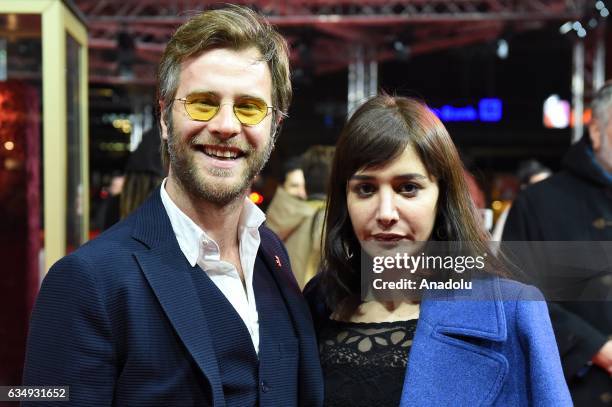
[306,277,572,407]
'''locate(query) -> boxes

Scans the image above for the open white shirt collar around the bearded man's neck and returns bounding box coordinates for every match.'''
[160,178,266,267]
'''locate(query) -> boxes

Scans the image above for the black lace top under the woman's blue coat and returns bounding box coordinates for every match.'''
[319,319,417,407]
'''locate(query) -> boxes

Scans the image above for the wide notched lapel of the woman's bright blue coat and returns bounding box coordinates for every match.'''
[401,278,509,406]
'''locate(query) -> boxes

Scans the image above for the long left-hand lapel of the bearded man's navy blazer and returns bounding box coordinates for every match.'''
[133,189,225,406]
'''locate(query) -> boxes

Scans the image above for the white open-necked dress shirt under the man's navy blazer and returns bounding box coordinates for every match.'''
[161,180,266,354]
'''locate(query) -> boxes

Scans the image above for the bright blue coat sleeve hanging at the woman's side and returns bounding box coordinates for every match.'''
[516,286,572,406]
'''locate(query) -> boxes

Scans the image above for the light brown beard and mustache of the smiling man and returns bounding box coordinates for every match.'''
[168,123,275,206]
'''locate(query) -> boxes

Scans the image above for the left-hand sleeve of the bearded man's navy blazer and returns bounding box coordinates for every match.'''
[23,255,116,406]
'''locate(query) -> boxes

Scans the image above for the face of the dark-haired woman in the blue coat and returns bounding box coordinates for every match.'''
[347,145,439,249]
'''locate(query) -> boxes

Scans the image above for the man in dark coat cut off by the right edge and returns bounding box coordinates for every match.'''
[503,83,612,406]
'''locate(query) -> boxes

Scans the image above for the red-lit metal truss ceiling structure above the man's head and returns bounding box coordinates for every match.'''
[75,0,594,85]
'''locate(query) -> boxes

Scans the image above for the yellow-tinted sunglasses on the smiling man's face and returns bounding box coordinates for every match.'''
[176,95,274,126]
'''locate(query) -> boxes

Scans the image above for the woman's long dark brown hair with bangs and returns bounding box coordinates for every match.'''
[321,95,502,314]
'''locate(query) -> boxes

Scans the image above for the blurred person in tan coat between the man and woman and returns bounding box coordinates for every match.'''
[266,145,334,288]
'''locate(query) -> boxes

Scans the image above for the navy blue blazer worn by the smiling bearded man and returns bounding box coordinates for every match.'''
[24,189,323,406]
